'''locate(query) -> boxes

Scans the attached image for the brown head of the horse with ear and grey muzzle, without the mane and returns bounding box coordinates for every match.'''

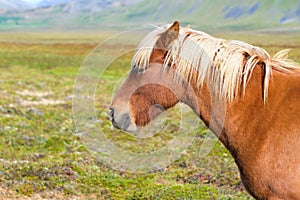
[108,22,184,132]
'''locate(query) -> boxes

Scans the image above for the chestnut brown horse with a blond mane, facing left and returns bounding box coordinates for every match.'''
[109,22,300,199]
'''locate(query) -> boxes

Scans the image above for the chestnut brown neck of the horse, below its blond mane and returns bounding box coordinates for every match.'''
[186,67,272,158]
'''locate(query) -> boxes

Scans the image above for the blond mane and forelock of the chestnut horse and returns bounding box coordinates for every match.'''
[132,25,296,102]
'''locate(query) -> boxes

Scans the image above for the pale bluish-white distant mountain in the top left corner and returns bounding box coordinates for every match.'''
[0,0,34,13]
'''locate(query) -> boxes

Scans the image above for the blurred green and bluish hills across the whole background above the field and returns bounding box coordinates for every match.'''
[0,0,300,30]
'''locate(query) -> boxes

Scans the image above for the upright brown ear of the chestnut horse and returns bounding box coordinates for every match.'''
[157,21,179,49]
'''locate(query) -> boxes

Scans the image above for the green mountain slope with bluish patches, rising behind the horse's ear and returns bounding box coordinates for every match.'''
[76,0,300,30]
